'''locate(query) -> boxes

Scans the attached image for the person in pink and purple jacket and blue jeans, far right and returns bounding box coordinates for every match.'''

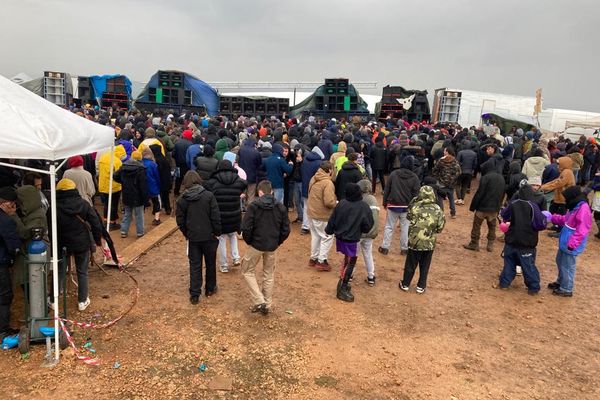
[548,186,592,297]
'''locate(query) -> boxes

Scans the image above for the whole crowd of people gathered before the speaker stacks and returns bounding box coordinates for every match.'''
[0,107,600,333]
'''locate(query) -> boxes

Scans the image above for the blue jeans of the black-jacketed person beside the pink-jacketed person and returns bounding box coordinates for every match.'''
[500,244,540,292]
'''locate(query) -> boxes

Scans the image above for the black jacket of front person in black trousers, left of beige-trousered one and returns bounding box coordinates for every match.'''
[175,185,221,242]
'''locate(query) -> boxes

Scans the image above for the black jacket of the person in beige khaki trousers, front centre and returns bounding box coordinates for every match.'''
[242,195,290,251]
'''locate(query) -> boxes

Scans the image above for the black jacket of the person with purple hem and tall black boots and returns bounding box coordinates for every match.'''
[325,189,374,243]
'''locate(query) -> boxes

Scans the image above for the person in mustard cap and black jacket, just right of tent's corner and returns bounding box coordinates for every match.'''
[114,150,150,238]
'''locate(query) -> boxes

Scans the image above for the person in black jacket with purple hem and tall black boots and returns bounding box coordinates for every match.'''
[325,183,375,302]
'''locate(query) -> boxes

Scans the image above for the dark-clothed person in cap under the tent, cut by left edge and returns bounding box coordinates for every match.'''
[0,186,21,340]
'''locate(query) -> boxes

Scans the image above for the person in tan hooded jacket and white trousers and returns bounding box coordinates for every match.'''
[305,161,337,271]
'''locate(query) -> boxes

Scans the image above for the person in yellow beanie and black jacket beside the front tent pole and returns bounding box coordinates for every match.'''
[56,178,102,311]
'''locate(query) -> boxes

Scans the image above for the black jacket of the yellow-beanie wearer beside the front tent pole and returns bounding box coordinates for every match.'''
[56,189,102,254]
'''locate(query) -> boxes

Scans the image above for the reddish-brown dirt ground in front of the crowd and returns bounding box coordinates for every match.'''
[0,188,600,400]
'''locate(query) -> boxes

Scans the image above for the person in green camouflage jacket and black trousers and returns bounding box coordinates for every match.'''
[398,186,446,293]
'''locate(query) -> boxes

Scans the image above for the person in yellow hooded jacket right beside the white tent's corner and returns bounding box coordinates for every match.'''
[98,145,127,231]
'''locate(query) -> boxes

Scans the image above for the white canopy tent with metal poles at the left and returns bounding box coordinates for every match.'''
[0,75,115,360]
